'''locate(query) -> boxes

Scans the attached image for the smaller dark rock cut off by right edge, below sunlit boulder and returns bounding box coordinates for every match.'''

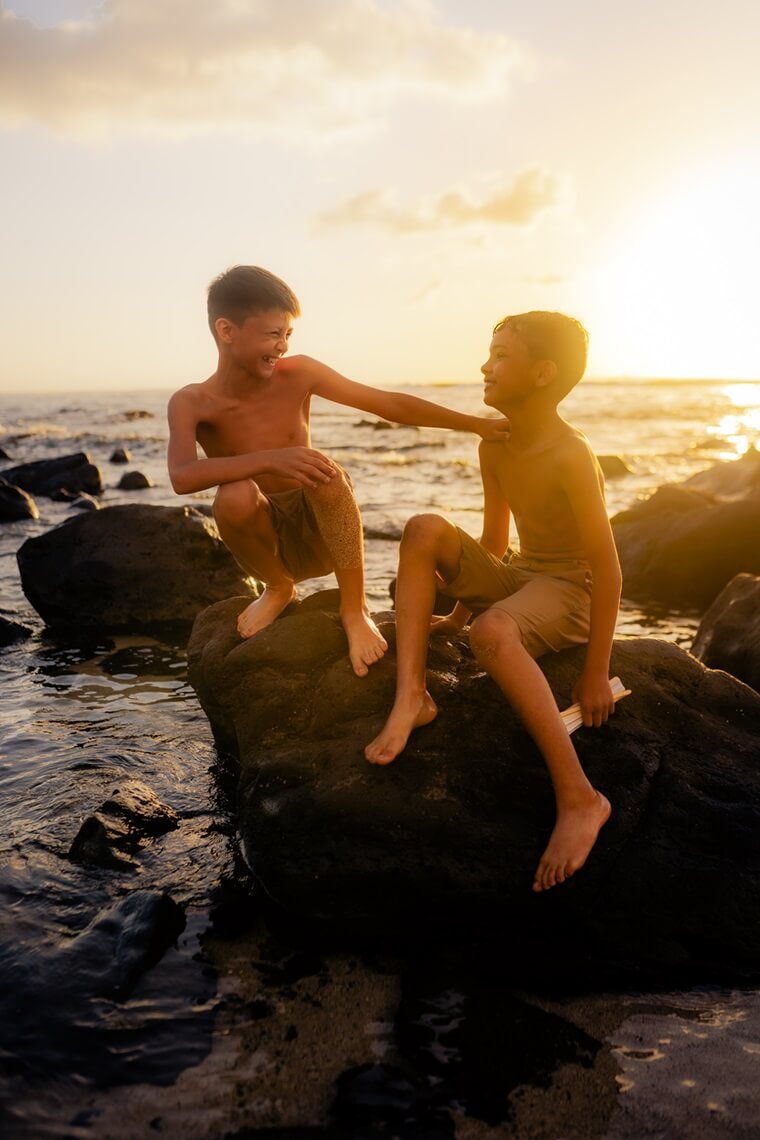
[692,573,760,691]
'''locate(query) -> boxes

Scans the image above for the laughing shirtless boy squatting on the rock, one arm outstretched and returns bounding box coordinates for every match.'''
[169,266,508,676]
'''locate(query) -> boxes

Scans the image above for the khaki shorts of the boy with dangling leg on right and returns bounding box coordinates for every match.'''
[439,527,591,658]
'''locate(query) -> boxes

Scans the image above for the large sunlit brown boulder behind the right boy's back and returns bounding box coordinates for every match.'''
[612,449,760,609]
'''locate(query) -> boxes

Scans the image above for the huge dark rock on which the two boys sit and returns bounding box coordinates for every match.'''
[188,595,760,976]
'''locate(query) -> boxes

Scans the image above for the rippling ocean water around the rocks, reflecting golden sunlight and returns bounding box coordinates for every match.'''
[0,380,760,1140]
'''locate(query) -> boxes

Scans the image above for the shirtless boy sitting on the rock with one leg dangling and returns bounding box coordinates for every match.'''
[366,312,621,890]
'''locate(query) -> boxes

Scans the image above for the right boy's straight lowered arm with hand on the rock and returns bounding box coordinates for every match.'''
[562,440,622,726]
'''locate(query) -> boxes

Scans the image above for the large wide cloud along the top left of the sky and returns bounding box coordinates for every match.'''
[0,0,521,135]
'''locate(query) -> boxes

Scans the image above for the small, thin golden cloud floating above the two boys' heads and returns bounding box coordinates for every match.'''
[317,168,564,234]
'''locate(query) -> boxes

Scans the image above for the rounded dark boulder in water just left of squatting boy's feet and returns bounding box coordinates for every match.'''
[17,505,257,630]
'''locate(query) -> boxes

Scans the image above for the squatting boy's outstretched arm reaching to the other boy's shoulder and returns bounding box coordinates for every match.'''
[301,357,509,440]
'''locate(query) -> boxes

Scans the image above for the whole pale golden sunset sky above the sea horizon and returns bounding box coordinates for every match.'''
[0,0,760,392]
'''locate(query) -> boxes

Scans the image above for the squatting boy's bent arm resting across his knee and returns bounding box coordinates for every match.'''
[166,390,335,495]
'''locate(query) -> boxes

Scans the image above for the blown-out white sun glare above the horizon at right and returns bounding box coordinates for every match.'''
[594,168,760,380]
